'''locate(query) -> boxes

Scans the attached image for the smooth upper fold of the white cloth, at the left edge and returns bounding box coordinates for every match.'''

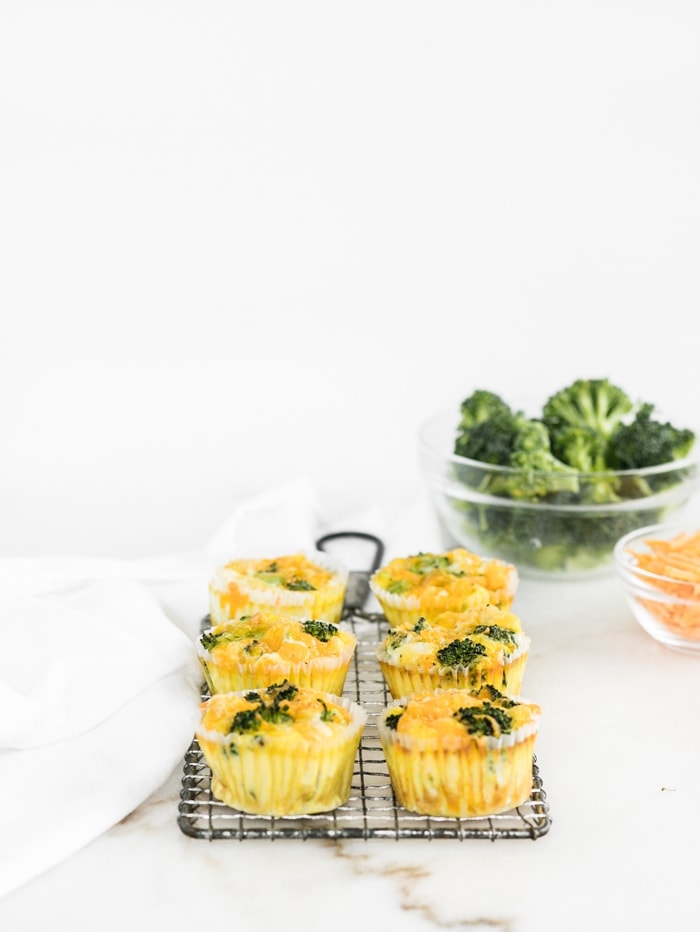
[0,579,201,748]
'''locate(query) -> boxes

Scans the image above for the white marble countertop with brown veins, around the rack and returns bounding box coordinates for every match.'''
[0,556,700,932]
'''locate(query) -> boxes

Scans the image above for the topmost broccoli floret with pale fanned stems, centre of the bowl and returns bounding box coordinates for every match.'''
[542,379,634,448]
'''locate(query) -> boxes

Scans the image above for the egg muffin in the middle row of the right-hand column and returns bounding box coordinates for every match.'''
[377,604,530,699]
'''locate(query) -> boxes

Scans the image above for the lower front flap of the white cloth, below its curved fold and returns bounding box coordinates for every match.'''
[0,671,197,897]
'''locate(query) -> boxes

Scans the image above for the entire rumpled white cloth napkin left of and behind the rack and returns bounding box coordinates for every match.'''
[0,477,438,896]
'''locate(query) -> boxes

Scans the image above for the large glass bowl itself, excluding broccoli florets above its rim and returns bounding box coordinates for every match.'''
[418,411,700,579]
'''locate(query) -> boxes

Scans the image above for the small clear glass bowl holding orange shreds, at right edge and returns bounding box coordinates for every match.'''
[615,523,700,653]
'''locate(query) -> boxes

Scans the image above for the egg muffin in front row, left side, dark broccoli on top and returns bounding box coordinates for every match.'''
[196,682,367,816]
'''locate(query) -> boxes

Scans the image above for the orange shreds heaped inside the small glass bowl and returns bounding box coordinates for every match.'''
[629,530,700,641]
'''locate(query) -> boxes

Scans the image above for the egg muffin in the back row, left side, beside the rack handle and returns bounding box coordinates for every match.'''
[209,551,349,624]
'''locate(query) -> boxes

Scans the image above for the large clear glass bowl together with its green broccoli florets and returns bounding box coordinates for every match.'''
[419,379,700,578]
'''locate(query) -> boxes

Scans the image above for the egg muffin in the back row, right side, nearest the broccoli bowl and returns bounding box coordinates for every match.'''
[370,547,518,628]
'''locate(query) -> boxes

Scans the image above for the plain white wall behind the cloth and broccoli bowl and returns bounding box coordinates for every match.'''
[0,0,700,556]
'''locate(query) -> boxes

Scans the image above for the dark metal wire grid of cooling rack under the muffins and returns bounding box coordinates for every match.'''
[177,612,551,841]
